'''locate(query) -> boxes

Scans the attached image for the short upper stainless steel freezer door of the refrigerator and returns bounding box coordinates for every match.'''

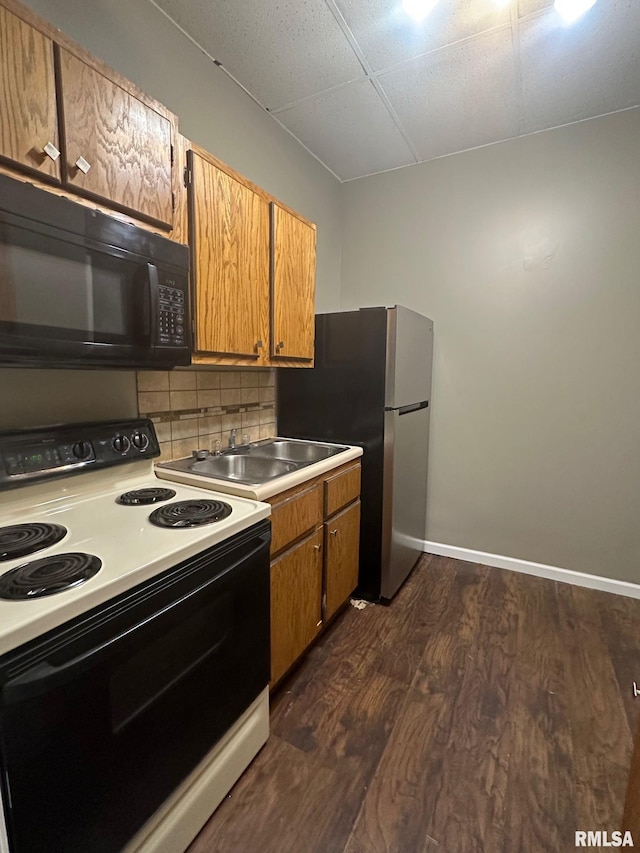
[385,305,433,409]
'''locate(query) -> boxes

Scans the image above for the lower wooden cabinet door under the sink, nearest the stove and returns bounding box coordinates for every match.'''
[271,528,322,684]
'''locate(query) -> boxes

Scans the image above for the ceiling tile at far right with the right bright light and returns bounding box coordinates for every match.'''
[520,0,640,132]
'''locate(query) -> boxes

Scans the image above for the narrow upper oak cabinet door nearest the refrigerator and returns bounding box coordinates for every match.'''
[271,202,316,361]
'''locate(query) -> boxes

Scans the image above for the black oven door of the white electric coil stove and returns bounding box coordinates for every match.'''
[0,521,270,853]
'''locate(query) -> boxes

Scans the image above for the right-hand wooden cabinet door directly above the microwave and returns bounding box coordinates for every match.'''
[60,48,173,226]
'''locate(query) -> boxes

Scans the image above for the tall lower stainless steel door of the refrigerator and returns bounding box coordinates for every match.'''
[380,408,430,600]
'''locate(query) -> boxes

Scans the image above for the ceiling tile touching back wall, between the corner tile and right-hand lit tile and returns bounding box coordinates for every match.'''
[378,30,518,160]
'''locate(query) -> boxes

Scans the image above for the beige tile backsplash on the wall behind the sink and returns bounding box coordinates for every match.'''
[137,368,277,459]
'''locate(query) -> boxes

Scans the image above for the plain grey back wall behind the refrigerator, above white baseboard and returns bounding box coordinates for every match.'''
[342,110,640,582]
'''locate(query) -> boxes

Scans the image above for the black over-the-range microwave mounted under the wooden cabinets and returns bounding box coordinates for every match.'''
[0,175,191,369]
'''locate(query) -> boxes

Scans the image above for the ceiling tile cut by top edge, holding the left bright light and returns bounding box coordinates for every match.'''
[336,0,510,71]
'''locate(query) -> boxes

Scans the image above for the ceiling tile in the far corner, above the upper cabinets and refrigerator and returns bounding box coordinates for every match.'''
[276,80,416,180]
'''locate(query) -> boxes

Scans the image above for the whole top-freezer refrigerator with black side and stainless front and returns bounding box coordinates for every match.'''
[277,305,433,602]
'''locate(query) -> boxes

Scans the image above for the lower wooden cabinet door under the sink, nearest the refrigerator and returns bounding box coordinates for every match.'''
[324,501,360,620]
